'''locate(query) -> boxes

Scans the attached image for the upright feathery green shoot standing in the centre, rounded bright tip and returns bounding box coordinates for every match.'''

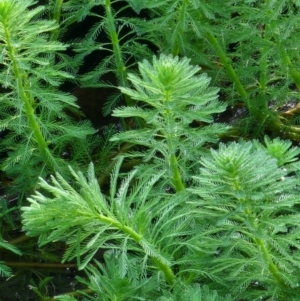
[111,55,226,191]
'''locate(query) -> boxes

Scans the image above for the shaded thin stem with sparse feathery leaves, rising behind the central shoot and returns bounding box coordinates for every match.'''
[73,0,150,116]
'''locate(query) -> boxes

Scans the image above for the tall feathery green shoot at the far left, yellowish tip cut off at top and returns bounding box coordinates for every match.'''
[0,0,94,191]
